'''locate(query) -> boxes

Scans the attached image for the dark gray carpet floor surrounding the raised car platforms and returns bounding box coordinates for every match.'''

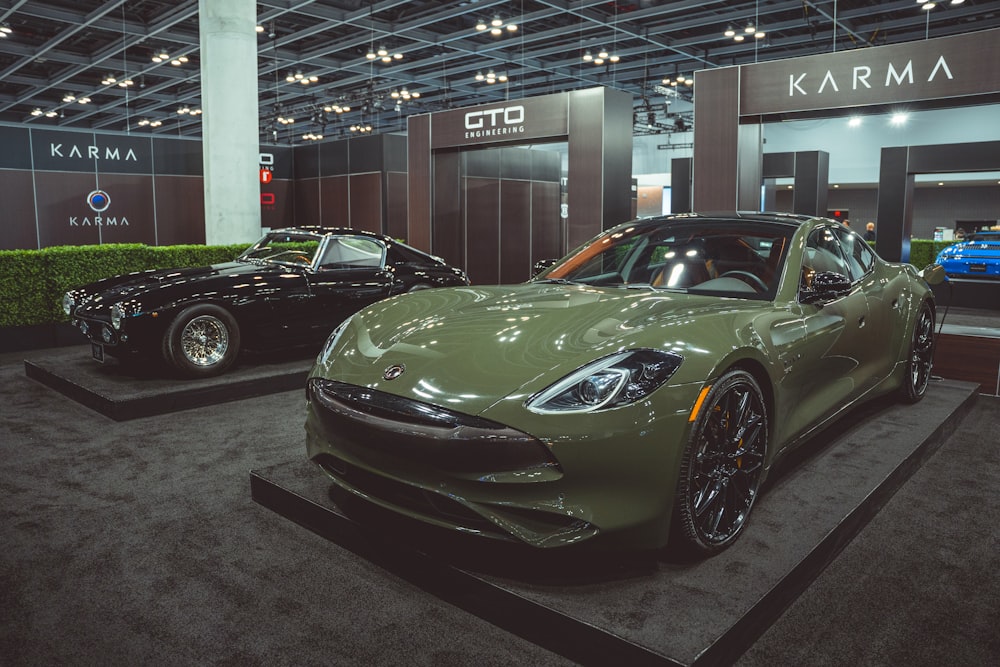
[0,350,1000,666]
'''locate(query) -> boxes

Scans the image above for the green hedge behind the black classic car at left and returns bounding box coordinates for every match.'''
[0,243,248,327]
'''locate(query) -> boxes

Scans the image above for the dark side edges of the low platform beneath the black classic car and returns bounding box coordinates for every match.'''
[24,359,310,421]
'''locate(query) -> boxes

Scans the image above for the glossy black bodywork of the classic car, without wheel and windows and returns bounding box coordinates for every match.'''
[68,227,468,366]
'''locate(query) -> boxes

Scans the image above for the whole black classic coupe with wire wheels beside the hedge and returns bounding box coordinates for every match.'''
[63,227,469,377]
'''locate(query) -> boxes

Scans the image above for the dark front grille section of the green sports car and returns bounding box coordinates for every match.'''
[308,378,561,475]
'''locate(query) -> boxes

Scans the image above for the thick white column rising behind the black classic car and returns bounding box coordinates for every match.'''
[198,0,260,245]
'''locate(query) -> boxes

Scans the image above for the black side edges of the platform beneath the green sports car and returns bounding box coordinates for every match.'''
[250,385,977,667]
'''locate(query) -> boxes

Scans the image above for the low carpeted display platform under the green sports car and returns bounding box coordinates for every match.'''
[250,380,977,665]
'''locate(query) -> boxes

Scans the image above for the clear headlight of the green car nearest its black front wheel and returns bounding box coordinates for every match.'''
[525,350,684,414]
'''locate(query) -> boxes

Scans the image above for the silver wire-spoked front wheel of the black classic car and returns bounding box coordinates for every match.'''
[163,303,240,377]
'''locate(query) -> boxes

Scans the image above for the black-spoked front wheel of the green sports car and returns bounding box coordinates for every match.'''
[671,369,768,558]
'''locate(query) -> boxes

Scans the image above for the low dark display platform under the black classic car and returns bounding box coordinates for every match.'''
[24,346,314,421]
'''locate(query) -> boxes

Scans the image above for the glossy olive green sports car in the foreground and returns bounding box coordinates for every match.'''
[306,214,942,555]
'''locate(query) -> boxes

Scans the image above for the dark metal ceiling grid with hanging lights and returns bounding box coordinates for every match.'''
[0,0,1000,143]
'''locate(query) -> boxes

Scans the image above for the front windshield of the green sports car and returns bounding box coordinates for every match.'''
[535,220,795,299]
